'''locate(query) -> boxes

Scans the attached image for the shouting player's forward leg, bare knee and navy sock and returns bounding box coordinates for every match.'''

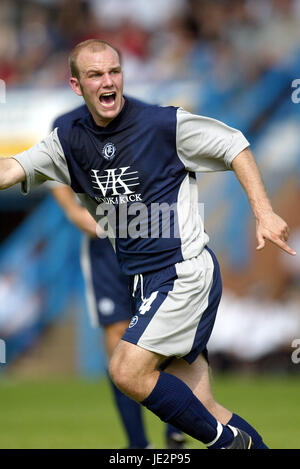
[110,340,240,448]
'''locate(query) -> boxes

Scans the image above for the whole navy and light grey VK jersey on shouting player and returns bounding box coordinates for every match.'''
[15,97,249,275]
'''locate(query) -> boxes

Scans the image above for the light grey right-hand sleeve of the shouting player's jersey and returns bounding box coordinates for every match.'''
[176,108,250,172]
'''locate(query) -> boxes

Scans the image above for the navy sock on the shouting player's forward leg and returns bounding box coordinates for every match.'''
[142,371,233,449]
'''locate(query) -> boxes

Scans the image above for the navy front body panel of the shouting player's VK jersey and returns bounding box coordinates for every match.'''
[58,99,186,274]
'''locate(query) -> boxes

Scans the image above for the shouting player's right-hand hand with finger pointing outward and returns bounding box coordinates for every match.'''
[256,211,296,256]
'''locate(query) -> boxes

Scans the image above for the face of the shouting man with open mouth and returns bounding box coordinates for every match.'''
[70,47,124,127]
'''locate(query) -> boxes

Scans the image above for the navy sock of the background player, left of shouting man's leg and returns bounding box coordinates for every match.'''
[109,378,149,448]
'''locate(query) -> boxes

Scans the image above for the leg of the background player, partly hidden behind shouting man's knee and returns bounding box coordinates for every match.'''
[104,321,149,448]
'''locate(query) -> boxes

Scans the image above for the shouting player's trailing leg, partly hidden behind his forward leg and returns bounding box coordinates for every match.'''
[165,354,268,449]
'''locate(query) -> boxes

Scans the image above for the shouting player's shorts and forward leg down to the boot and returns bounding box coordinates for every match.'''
[110,250,251,449]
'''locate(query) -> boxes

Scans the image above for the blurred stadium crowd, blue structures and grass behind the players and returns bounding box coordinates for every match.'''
[0,0,300,448]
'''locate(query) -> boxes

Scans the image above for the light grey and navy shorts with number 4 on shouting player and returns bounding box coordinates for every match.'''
[123,248,222,363]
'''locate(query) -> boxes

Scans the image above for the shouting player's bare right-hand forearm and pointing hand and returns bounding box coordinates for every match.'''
[232,148,296,255]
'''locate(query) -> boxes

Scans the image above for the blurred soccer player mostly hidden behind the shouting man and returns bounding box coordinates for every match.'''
[50,177,184,449]
